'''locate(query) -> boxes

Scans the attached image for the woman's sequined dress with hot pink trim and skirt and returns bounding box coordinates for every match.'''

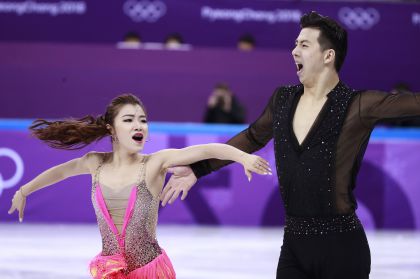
[89,156,176,279]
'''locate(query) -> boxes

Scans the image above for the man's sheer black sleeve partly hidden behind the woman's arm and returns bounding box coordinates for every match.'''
[190,90,279,178]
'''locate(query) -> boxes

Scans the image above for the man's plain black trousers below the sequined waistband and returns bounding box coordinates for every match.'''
[276,229,370,279]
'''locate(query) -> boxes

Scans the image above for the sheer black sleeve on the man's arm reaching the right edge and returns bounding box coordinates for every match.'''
[359,91,420,128]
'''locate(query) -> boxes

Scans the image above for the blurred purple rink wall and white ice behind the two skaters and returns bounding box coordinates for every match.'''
[0,0,420,279]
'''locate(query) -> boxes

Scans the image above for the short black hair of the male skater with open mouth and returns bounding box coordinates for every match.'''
[300,12,347,72]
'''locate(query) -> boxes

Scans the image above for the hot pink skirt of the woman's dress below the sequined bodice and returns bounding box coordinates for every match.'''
[89,250,176,279]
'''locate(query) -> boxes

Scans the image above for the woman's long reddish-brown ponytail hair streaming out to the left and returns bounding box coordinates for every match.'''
[29,94,146,150]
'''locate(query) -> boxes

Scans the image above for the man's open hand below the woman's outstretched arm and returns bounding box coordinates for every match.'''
[160,166,197,206]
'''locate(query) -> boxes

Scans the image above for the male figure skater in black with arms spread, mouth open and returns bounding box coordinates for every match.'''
[161,12,420,279]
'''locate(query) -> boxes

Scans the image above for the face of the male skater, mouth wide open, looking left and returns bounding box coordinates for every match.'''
[292,28,325,85]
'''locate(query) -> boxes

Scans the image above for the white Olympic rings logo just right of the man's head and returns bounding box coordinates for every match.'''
[338,7,380,30]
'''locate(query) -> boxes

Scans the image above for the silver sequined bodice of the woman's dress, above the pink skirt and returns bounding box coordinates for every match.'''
[92,156,162,272]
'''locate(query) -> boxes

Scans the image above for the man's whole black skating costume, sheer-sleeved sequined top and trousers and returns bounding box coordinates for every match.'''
[192,82,420,279]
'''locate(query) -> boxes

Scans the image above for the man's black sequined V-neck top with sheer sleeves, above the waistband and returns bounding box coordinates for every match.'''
[191,82,420,217]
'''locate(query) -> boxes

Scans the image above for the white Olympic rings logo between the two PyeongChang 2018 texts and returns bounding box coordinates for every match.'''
[123,0,166,22]
